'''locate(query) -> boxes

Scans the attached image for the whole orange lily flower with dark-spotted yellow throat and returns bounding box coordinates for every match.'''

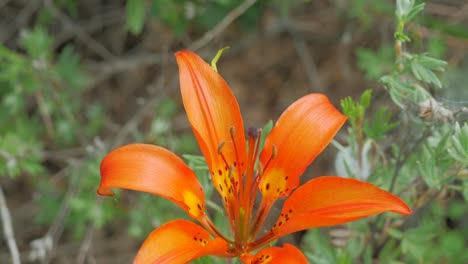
[98,51,411,264]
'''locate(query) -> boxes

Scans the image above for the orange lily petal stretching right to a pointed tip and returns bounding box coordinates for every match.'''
[272,176,411,238]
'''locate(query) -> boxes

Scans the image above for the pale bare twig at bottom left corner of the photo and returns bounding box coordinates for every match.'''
[0,186,21,264]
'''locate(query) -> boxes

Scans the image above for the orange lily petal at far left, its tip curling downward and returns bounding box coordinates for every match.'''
[98,144,205,218]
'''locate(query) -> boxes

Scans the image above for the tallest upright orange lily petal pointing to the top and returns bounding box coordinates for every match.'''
[175,50,246,198]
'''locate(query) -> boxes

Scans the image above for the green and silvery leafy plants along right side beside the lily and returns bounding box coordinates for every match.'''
[324,0,468,263]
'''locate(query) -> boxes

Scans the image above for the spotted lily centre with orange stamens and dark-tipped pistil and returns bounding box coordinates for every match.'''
[211,127,278,253]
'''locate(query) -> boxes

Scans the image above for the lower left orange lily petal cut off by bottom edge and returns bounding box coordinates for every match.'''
[133,220,228,264]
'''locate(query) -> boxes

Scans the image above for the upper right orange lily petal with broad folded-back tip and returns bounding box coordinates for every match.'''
[259,94,346,199]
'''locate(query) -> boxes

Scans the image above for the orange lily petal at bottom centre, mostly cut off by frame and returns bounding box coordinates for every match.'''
[241,244,309,264]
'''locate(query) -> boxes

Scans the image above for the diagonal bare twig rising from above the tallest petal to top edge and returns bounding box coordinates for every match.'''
[189,0,257,50]
